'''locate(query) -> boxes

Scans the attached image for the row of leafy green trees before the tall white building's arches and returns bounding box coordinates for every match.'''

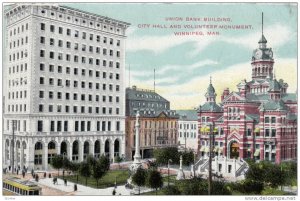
[50,155,110,187]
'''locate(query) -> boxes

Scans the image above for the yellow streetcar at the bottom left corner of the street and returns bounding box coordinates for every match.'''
[3,177,42,195]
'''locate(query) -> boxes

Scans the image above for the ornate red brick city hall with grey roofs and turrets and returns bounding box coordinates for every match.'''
[198,34,297,163]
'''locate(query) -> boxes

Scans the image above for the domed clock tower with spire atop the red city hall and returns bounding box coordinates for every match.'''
[251,14,274,80]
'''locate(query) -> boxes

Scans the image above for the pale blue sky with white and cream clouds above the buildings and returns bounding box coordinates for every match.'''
[66,3,298,109]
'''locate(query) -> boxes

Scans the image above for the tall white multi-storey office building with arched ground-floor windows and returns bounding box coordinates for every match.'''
[3,4,129,170]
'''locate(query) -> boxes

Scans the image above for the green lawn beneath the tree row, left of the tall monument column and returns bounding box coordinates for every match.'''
[60,170,129,188]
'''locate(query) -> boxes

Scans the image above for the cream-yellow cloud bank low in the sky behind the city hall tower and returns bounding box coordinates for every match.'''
[130,59,297,109]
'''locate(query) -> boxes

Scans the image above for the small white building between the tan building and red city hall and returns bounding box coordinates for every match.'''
[176,110,198,153]
